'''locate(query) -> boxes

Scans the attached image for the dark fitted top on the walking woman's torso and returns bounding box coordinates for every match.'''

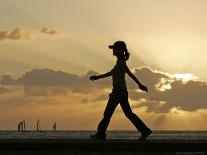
[111,59,127,88]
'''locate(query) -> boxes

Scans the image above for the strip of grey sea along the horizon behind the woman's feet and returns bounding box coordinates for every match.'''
[0,130,207,140]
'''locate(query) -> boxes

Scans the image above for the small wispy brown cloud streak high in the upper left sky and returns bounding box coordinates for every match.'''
[0,27,63,41]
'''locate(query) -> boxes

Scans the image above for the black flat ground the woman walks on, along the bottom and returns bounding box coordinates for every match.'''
[0,139,207,155]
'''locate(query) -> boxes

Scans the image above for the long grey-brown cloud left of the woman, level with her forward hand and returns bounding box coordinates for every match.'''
[11,69,101,96]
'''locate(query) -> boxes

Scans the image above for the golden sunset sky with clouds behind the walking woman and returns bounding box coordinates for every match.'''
[0,0,207,130]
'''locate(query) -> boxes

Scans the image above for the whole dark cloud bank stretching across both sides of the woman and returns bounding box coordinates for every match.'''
[0,67,207,112]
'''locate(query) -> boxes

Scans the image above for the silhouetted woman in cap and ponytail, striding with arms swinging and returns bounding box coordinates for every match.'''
[90,41,152,140]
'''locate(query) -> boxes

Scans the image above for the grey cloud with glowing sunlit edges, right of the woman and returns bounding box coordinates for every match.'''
[130,68,207,112]
